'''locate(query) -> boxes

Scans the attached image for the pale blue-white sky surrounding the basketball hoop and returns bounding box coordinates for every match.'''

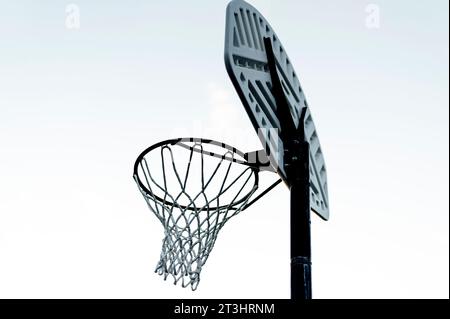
[0,0,449,298]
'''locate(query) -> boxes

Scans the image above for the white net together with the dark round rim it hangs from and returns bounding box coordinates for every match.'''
[134,139,259,290]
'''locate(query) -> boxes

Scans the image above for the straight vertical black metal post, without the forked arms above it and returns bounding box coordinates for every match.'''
[291,141,312,301]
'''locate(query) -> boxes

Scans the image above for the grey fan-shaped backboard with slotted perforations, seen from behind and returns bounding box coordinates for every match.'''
[225,0,329,220]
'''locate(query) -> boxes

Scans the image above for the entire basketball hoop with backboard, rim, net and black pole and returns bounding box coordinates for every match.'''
[134,0,330,301]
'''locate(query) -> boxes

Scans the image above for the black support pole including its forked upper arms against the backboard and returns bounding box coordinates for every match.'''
[264,38,312,301]
